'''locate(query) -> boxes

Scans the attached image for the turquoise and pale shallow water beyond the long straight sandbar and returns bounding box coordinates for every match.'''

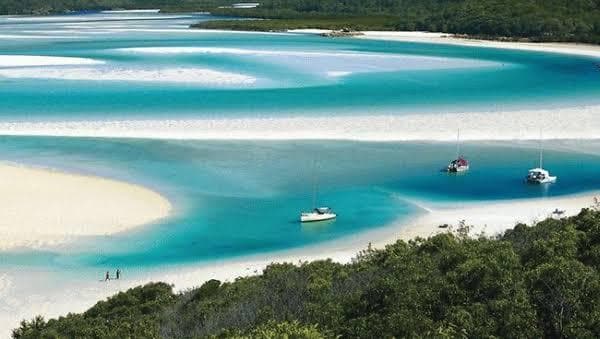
[0,14,600,120]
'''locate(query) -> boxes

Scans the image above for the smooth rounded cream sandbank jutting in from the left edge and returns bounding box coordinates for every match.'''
[0,164,171,250]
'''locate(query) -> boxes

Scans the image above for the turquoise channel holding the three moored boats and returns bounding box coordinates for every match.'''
[0,137,600,269]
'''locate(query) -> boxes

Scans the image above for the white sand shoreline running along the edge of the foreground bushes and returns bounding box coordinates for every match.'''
[0,191,600,336]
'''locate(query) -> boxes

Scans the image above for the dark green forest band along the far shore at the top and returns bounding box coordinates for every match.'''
[0,0,600,43]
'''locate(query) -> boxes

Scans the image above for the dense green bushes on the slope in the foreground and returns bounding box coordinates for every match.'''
[13,209,600,338]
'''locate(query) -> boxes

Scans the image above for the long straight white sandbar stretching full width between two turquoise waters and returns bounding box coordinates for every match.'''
[0,106,600,141]
